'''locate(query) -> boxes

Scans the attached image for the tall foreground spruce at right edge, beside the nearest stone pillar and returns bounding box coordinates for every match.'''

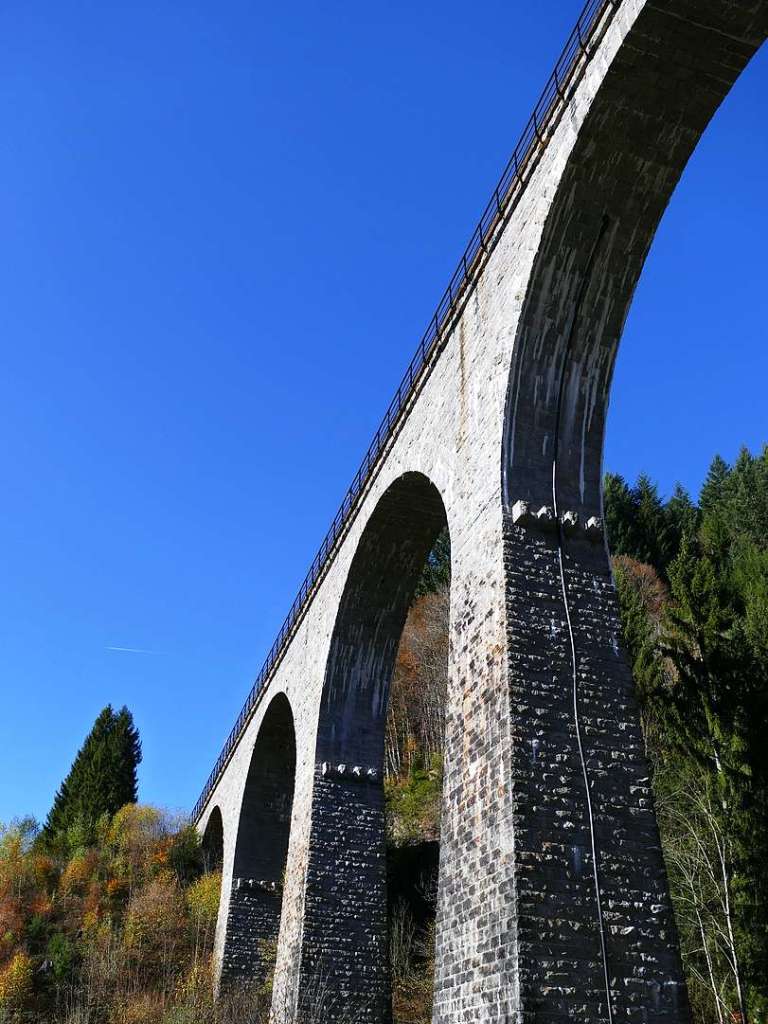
[663,536,768,1013]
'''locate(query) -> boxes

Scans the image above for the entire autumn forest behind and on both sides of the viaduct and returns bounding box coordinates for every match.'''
[0,447,768,1024]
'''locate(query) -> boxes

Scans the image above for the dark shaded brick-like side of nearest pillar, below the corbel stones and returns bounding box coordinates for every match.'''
[506,518,686,1024]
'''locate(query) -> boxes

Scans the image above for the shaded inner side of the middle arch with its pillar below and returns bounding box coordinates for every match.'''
[300,472,447,1024]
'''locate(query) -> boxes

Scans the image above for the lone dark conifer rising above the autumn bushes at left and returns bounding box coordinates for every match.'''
[44,705,141,840]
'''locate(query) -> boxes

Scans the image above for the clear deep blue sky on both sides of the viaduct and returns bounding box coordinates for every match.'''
[0,0,768,820]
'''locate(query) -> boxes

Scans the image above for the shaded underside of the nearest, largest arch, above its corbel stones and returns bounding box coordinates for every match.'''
[503,0,768,518]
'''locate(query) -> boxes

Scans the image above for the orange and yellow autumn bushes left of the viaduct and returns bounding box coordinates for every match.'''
[0,804,221,1024]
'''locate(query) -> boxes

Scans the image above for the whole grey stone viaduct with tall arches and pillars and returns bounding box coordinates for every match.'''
[195,0,768,1024]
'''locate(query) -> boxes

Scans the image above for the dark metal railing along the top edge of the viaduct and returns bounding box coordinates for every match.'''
[193,0,621,821]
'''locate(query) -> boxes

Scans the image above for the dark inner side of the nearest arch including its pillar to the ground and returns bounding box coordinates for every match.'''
[502,0,768,1021]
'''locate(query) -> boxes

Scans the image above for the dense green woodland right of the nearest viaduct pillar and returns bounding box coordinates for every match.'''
[605,449,768,1019]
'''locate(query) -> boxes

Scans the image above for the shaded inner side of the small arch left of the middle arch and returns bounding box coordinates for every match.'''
[221,693,296,984]
